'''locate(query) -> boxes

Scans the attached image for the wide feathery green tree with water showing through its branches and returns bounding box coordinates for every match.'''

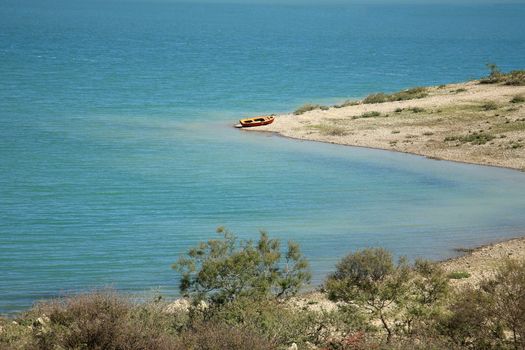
[173,227,311,304]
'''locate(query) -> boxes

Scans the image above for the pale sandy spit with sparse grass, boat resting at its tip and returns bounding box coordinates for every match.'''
[244,81,525,171]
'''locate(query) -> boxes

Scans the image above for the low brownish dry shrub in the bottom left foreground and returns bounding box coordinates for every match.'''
[30,292,175,350]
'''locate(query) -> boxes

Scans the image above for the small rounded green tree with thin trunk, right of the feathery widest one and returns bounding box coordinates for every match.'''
[325,248,410,342]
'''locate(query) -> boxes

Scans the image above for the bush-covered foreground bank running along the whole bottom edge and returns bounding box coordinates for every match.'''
[0,228,525,350]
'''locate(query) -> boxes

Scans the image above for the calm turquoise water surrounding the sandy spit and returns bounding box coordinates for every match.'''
[0,0,525,312]
